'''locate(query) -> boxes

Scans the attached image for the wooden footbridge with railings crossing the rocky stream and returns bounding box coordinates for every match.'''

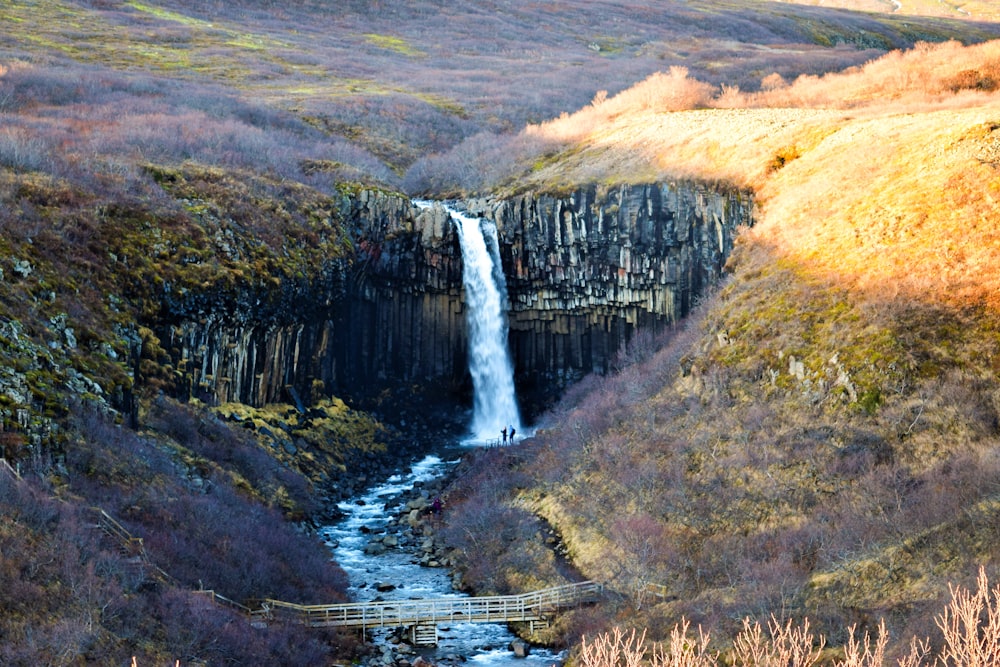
[264,581,604,644]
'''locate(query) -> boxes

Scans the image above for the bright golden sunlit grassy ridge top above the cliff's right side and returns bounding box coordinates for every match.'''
[518,43,1000,309]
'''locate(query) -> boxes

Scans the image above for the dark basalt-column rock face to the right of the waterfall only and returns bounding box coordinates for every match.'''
[470,183,752,402]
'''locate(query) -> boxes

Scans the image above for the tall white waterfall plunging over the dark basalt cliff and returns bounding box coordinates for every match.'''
[449,209,524,440]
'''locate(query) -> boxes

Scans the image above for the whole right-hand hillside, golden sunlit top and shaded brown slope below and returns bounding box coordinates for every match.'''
[440,39,1000,652]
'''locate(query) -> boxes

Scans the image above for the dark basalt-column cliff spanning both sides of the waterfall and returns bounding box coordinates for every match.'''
[161,183,753,418]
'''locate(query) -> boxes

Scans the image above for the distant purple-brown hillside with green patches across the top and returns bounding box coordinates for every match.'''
[0,0,1000,181]
